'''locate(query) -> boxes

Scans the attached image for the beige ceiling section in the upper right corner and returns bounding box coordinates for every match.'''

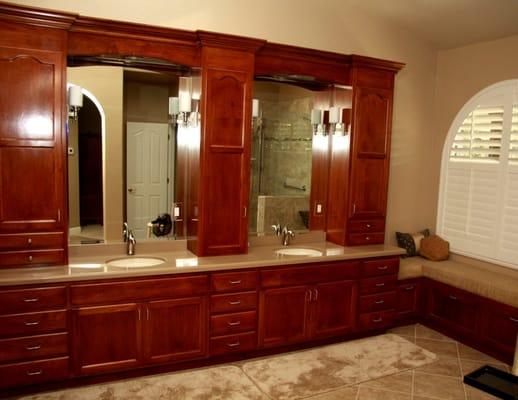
[356,0,518,50]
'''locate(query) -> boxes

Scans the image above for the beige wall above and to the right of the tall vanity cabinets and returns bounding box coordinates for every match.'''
[18,0,442,243]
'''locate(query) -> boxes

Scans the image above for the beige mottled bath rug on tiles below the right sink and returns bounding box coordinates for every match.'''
[243,334,436,400]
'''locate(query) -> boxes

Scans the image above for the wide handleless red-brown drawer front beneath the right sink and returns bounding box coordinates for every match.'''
[260,261,360,287]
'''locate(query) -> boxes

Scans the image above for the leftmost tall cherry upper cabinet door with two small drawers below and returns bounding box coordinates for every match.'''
[0,44,67,266]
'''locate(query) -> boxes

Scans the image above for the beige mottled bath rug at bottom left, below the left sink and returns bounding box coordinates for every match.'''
[19,365,267,400]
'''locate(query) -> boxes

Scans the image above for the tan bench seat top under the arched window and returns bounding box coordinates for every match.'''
[398,256,518,307]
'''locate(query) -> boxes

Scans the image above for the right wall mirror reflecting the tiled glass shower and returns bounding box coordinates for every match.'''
[249,76,352,235]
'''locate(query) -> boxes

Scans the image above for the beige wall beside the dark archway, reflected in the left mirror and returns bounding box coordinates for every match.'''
[67,67,124,242]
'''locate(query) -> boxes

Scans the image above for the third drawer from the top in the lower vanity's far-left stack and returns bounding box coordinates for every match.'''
[0,333,68,363]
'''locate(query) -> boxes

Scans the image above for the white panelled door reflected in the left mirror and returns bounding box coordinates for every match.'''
[126,122,169,238]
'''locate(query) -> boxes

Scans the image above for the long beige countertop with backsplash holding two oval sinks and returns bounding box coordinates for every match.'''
[0,236,404,286]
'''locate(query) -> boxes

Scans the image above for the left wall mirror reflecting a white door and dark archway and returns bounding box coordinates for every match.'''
[67,57,201,244]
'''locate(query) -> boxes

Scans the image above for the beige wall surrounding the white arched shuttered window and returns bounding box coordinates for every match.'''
[430,35,518,228]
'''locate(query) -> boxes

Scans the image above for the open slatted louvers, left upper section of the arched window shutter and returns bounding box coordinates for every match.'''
[450,106,504,161]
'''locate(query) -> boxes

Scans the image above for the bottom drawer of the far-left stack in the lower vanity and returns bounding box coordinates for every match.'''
[0,357,68,388]
